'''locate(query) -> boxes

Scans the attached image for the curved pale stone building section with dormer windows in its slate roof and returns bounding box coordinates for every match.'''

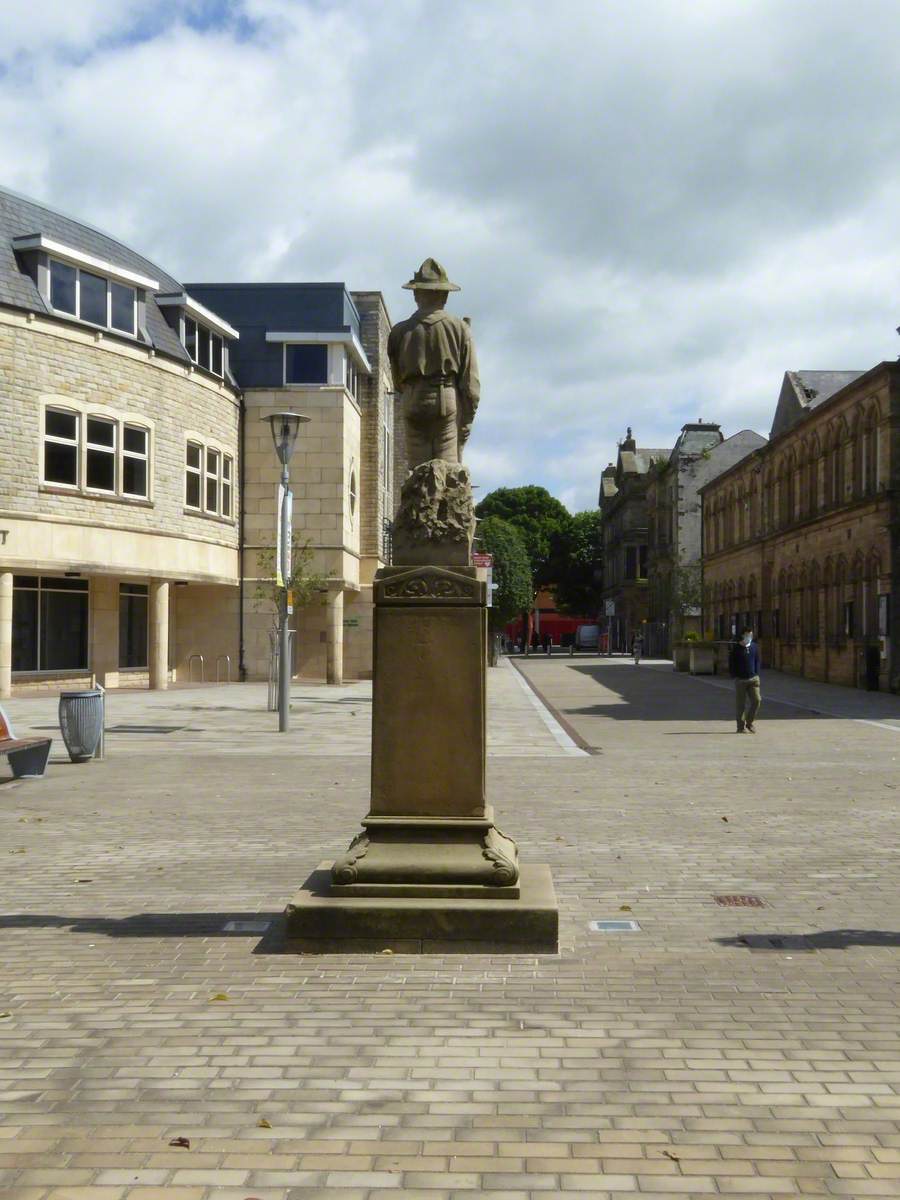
[0,191,240,695]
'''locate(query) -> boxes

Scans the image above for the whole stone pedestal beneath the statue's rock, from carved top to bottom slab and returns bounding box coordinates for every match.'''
[286,556,558,953]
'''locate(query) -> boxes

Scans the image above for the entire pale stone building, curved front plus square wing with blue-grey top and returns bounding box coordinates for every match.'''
[0,184,402,696]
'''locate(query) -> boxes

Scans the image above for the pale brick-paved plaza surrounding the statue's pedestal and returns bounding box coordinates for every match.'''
[0,658,900,1200]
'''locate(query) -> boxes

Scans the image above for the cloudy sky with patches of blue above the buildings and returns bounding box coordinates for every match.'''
[0,0,900,509]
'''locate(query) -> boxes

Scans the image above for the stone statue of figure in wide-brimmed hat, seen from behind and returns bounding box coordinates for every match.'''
[388,258,479,470]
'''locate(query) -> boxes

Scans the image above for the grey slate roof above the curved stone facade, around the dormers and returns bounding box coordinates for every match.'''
[0,188,198,364]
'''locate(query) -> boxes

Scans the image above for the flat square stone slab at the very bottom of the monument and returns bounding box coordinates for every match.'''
[284,862,559,954]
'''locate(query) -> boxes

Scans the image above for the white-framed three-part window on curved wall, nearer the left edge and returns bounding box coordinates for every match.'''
[41,404,150,500]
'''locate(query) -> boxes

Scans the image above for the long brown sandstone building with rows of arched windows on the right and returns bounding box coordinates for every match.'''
[701,362,900,690]
